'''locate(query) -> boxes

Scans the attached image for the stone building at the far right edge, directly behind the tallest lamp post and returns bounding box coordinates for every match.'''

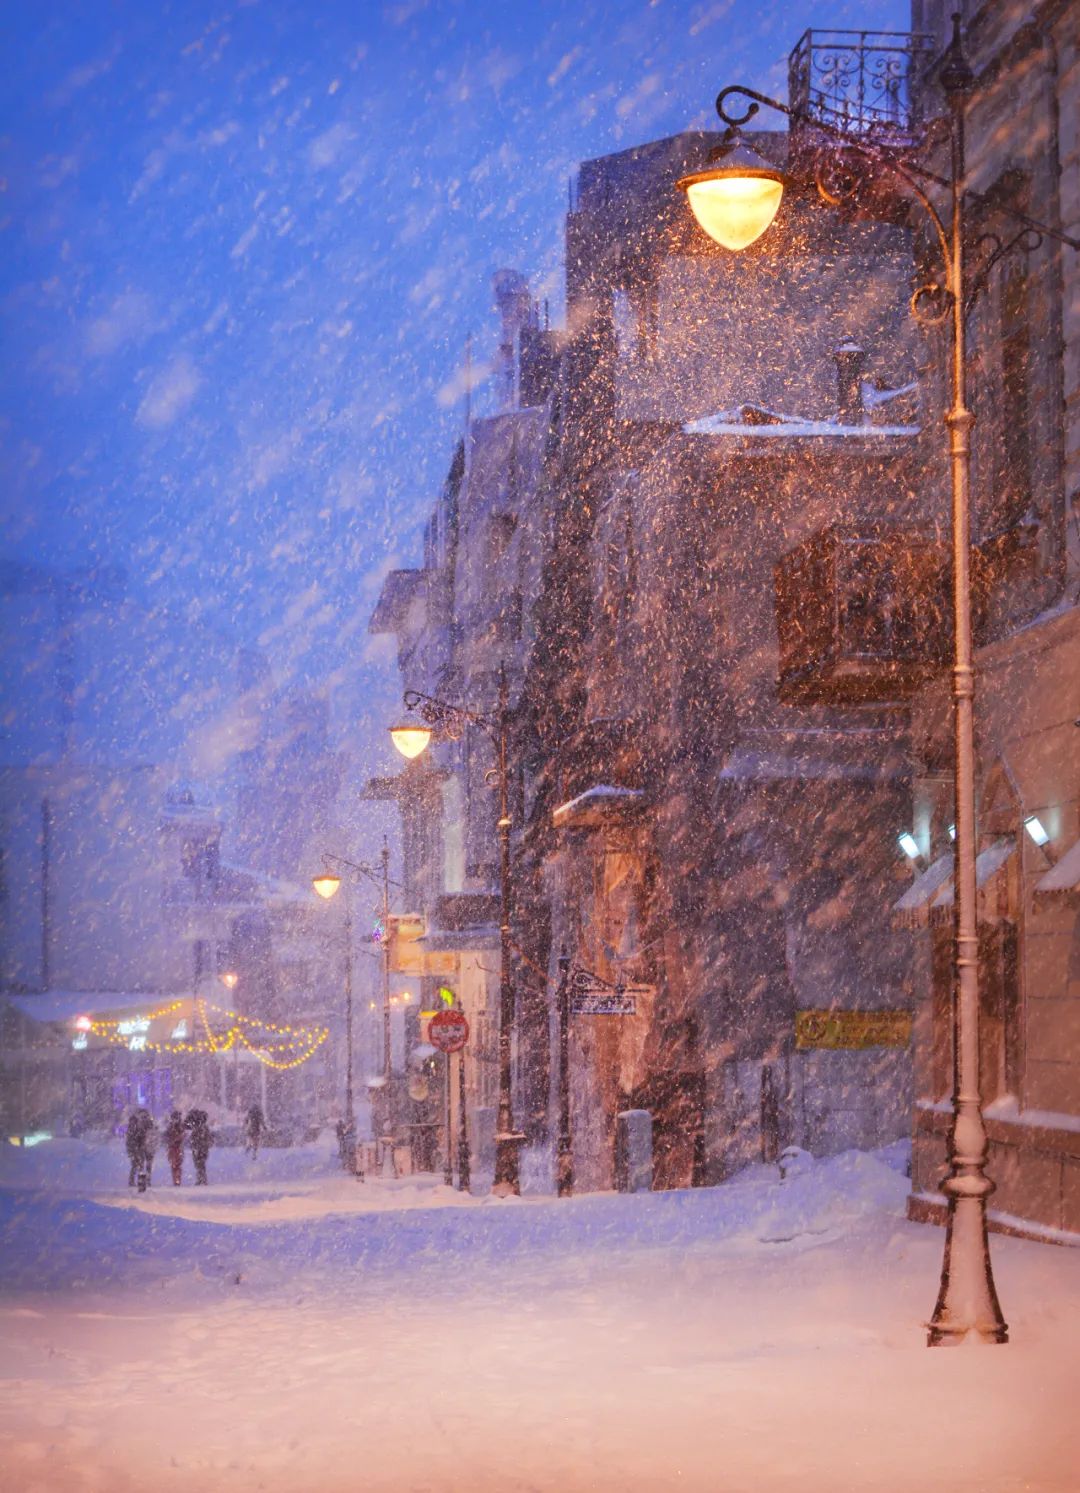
[908,0,1080,1238]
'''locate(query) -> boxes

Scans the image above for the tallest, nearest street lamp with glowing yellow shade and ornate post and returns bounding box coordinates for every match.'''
[678,13,1080,1347]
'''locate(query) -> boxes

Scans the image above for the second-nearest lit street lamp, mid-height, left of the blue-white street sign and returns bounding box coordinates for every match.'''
[390,664,524,1193]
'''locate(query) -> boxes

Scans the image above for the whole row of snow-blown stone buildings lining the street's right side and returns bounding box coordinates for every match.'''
[372,0,1080,1230]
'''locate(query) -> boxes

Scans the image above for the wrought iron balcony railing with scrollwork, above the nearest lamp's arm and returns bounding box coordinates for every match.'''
[787,31,934,146]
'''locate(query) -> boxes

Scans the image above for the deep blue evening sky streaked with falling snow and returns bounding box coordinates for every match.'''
[0,0,907,734]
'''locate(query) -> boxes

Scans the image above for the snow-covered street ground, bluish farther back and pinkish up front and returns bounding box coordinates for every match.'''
[0,1141,1080,1493]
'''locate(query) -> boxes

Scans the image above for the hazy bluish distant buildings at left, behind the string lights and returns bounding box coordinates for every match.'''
[0,564,341,1133]
